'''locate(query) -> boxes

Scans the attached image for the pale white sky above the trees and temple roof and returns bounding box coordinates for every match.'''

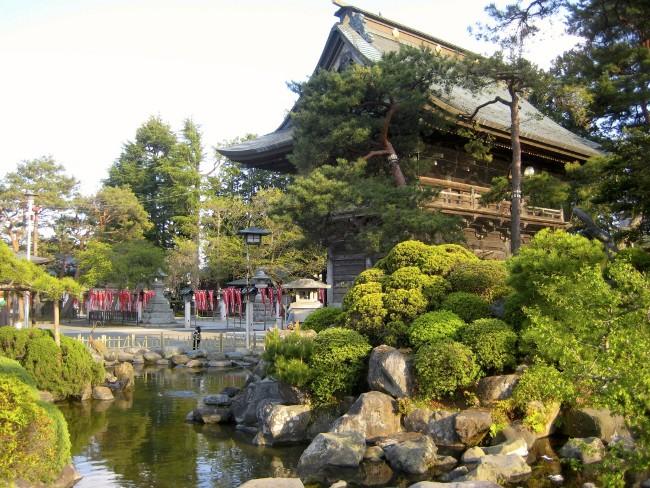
[0,0,575,194]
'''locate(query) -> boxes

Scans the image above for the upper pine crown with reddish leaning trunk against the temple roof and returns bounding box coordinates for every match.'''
[290,47,449,187]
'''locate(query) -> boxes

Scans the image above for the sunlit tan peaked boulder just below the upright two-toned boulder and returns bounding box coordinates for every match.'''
[331,391,402,440]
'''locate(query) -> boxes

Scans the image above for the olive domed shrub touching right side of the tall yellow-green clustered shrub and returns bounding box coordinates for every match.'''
[447,261,507,302]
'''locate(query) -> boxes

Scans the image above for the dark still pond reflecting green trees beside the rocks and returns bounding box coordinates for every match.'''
[60,368,305,488]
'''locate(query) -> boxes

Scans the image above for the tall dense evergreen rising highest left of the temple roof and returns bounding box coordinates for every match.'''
[106,117,203,249]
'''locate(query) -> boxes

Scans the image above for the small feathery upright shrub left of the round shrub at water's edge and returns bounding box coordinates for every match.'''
[262,330,314,387]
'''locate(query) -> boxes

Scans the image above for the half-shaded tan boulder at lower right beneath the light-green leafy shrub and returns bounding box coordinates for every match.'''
[562,408,630,443]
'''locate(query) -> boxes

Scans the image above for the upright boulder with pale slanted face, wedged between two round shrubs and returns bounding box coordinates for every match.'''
[368,346,414,398]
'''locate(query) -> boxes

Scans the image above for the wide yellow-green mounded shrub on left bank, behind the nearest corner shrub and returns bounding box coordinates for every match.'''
[0,327,104,398]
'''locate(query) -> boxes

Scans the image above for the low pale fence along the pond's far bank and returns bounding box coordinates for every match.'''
[76,331,264,352]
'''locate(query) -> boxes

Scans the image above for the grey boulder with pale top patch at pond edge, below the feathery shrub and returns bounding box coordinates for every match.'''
[254,403,311,446]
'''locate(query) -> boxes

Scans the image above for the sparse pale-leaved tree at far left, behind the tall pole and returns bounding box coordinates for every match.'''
[0,156,79,255]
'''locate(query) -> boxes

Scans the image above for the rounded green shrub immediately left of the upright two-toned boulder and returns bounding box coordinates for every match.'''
[310,327,372,405]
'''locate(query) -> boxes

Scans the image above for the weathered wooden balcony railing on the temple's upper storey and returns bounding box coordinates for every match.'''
[420,176,565,226]
